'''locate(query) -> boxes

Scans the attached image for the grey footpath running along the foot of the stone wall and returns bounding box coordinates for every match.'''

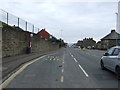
[2,49,59,81]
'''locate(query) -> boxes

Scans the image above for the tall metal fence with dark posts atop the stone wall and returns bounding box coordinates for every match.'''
[0,9,40,33]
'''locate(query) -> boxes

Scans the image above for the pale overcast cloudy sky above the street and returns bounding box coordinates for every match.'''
[0,0,118,43]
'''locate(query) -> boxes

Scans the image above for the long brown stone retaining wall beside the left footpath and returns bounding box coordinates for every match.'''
[2,26,59,57]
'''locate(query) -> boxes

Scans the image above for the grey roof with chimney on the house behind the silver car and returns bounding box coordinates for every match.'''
[101,30,120,40]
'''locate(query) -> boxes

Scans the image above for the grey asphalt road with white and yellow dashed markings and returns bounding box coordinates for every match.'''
[6,48,119,88]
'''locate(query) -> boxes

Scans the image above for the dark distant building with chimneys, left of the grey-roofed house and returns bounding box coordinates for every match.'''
[76,38,96,48]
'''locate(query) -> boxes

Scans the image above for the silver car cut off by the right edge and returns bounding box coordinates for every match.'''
[100,46,120,80]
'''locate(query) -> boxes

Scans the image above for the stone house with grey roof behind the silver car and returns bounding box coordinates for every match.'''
[101,30,120,49]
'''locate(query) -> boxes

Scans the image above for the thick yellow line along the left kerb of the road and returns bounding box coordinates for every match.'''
[0,55,46,88]
